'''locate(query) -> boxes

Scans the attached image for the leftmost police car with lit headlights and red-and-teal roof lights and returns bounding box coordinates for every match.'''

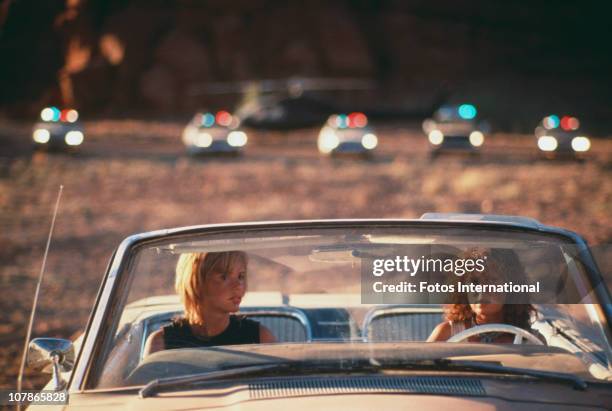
[32,107,85,152]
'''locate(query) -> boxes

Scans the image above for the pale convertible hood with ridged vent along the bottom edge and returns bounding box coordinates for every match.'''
[63,376,612,411]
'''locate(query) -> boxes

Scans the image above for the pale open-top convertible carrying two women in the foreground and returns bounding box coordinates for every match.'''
[28,214,612,411]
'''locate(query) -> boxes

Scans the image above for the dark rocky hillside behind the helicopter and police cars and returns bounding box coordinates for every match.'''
[0,0,612,129]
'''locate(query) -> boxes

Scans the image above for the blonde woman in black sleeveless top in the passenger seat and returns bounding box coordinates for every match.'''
[145,251,275,355]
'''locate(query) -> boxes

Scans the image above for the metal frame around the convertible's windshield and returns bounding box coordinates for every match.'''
[69,219,612,392]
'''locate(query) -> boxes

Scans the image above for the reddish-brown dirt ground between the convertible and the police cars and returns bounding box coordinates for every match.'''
[0,120,612,388]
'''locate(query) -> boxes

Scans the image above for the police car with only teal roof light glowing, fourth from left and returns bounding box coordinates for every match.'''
[423,103,489,156]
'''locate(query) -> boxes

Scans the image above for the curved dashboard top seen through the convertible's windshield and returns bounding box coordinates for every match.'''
[128,342,592,385]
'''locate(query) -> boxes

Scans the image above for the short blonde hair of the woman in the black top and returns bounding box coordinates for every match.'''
[174,251,248,324]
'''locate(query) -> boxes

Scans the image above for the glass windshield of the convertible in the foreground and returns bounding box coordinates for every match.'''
[88,223,612,388]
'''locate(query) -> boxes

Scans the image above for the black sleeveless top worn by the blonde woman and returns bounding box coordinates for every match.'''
[164,315,260,350]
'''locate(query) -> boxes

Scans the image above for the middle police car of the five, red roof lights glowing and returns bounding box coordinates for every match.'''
[317,112,378,157]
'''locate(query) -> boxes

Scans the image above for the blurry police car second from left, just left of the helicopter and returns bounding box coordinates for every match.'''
[182,110,248,155]
